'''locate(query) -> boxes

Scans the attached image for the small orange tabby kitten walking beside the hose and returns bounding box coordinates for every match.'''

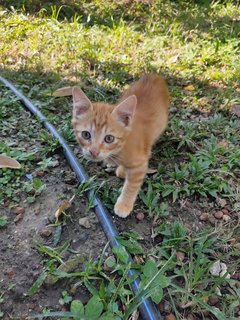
[72,74,169,218]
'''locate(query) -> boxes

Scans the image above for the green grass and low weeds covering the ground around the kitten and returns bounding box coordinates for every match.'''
[0,0,240,319]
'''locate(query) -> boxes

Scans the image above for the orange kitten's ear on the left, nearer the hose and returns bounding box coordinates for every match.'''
[72,87,92,118]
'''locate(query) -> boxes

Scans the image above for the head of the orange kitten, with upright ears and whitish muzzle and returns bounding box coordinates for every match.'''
[72,87,137,161]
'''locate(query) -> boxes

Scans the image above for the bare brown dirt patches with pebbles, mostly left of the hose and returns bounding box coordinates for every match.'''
[0,151,214,320]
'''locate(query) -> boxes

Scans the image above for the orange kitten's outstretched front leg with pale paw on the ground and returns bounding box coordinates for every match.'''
[114,163,148,218]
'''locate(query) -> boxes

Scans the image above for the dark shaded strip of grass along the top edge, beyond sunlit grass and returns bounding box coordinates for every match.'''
[1,0,240,42]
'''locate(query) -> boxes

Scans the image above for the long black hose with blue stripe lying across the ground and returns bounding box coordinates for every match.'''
[0,76,161,320]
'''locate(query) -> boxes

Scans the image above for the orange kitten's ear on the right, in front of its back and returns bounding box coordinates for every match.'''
[112,95,137,127]
